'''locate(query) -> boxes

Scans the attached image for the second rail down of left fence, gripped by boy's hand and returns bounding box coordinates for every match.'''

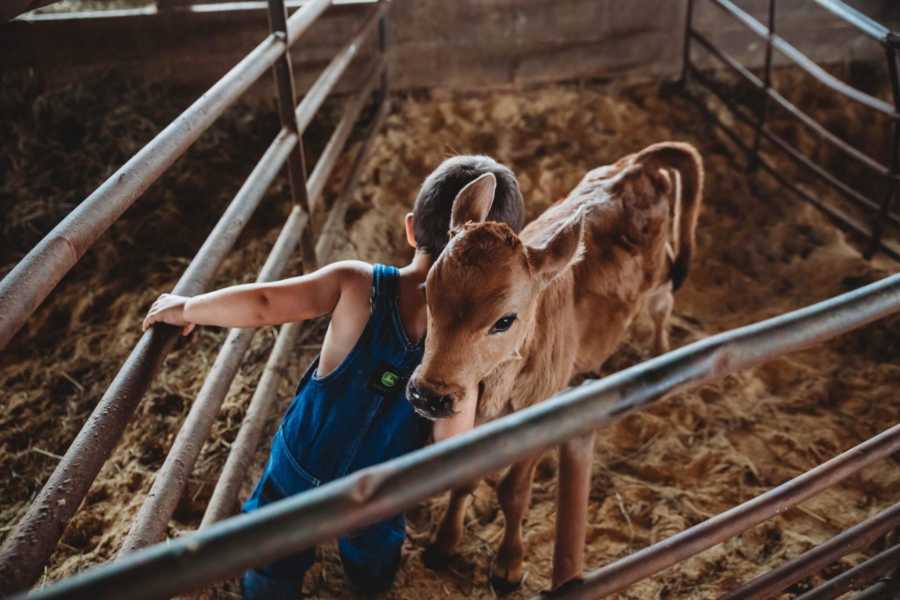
[0,125,298,594]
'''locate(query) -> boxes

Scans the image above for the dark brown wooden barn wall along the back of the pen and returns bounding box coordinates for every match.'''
[0,0,898,92]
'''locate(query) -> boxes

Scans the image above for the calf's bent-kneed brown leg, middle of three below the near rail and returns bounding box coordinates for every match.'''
[491,456,540,593]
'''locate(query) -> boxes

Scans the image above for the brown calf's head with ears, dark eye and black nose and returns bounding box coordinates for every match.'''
[407,173,582,427]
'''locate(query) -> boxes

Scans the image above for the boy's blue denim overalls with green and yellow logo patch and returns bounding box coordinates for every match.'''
[242,265,431,600]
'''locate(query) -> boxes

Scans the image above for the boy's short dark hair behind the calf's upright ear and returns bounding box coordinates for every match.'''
[413,155,525,258]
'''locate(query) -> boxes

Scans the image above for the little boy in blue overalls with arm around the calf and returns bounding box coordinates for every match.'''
[143,156,524,599]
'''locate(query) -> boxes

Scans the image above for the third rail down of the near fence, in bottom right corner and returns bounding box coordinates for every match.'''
[720,503,900,600]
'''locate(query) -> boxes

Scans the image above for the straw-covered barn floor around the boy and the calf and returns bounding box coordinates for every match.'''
[0,68,900,600]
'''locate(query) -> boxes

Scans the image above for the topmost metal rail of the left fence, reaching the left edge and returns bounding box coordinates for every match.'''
[0,0,330,350]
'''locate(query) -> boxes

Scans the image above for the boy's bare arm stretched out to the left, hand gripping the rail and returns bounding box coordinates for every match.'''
[143,261,371,335]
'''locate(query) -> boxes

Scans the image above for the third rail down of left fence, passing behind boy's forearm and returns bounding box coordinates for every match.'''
[119,208,308,555]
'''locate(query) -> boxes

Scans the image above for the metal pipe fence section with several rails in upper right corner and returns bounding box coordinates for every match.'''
[680,0,900,257]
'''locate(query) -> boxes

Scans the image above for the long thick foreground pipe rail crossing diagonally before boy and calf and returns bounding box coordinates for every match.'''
[17,274,900,600]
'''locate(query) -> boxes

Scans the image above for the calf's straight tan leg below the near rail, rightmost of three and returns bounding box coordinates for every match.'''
[553,432,594,589]
